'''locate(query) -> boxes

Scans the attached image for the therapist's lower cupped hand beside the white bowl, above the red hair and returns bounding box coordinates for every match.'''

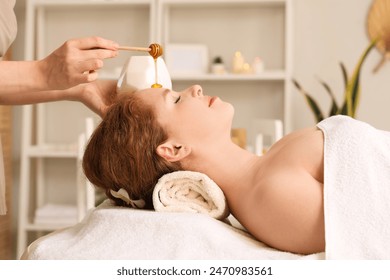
[74,80,117,118]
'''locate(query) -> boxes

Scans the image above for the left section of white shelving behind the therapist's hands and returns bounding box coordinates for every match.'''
[17,0,156,256]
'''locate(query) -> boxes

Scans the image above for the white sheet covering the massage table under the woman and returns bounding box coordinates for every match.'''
[22,201,324,260]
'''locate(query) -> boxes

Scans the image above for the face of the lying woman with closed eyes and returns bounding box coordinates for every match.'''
[135,85,234,147]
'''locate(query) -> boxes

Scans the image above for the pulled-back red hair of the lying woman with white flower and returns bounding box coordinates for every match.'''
[83,94,181,209]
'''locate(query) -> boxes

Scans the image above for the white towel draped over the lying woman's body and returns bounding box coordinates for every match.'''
[318,116,390,259]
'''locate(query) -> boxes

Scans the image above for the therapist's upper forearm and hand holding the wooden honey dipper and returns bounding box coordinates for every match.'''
[0,37,117,100]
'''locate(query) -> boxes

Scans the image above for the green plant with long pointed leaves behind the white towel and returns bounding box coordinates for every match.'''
[293,40,377,122]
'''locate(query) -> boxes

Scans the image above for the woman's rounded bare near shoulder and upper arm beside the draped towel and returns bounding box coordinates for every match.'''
[242,164,324,253]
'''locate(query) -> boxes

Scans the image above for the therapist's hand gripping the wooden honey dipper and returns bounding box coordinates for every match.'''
[39,37,118,89]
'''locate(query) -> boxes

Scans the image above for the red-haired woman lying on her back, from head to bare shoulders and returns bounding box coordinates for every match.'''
[83,85,390,254]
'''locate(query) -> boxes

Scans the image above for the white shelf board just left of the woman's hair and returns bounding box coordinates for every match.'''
[27,145,78,158]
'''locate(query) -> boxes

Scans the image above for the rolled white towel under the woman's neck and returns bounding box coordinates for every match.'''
[153,171,229,220]
